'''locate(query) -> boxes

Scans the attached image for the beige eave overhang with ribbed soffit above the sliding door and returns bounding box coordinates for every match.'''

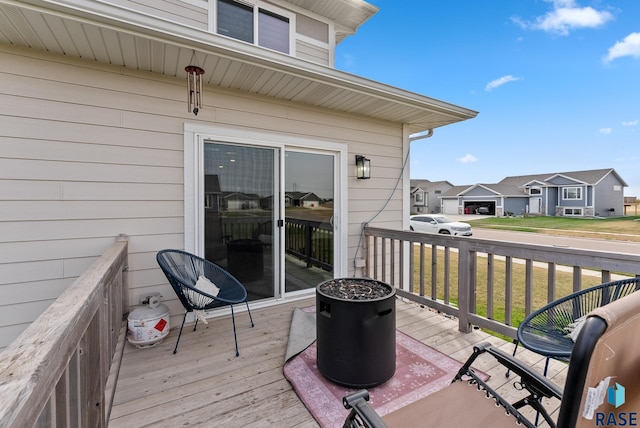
[0,0,477,133]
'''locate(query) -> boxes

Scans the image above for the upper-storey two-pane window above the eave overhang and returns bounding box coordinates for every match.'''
[216,0,291,54]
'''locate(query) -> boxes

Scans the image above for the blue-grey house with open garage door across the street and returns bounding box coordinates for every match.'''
[442,168,627,217]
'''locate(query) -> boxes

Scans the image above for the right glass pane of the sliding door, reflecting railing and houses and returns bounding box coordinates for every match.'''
[284,150,334,293]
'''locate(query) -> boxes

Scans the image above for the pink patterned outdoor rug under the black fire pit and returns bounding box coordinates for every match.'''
[284,330,489,428]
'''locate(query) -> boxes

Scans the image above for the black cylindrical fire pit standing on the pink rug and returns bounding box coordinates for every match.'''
[316,278,396,388]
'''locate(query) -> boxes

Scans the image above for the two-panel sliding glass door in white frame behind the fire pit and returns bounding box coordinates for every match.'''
[201,140,336,301]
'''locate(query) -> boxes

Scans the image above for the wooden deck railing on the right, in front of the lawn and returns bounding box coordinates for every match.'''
[364,227,640,339]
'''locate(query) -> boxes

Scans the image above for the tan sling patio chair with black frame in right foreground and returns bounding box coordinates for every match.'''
[343,293,640,428]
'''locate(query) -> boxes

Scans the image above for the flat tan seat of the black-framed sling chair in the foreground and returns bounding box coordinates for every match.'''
[382,382,516,428]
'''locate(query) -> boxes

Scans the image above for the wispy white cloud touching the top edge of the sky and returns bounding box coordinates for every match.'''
[512,0,613,36]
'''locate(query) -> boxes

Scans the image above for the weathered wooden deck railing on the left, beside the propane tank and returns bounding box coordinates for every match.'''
[0,236,128,428]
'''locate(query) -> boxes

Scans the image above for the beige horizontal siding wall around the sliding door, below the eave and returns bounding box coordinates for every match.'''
[0,45,402,349]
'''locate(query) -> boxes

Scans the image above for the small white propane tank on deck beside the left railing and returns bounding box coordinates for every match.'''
[127,293,169,348]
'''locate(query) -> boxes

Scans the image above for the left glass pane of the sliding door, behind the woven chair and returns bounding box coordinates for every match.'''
[204,141,280,300]
